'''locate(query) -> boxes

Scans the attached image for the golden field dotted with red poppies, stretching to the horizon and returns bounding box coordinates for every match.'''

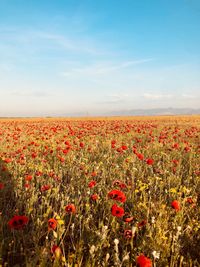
[0,116,200,267]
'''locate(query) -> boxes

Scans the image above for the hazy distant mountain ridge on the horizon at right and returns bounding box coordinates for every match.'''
[106,108,200,116]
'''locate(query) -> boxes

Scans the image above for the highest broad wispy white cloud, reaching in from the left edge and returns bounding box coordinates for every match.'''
[0,26,105,56]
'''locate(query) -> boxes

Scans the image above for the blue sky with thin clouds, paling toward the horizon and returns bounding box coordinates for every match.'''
[0,0,200,116]
